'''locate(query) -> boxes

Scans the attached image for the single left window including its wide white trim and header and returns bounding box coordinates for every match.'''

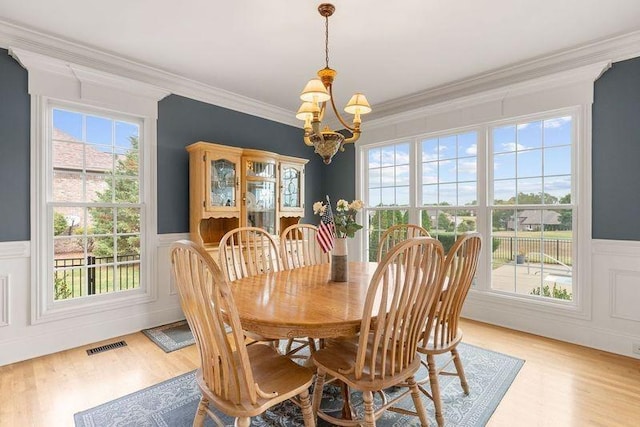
[12,49,168,324]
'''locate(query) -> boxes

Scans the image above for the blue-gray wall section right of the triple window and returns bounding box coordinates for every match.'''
[592,58,640,240]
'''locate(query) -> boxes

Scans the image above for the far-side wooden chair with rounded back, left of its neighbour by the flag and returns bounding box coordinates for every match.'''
[218,227,281,347]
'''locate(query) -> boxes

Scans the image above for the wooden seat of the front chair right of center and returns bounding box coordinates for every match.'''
[312,335,420,391]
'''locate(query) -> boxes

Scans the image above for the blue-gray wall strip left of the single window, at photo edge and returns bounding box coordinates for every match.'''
[0,49,31,242]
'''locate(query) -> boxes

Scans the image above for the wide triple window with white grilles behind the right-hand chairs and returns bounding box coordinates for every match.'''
[360,110,577,303]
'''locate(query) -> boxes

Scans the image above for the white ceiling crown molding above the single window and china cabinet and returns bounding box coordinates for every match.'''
[0,20,300,127]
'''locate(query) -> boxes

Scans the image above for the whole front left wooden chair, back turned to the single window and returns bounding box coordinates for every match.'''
[171,240,315,426]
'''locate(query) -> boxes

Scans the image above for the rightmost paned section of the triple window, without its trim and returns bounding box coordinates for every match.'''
[490,116,574,300]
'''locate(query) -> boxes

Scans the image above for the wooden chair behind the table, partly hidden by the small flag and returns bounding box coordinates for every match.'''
[280,224,331,356]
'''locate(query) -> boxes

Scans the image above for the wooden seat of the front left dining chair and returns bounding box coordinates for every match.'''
[196,343,313,417]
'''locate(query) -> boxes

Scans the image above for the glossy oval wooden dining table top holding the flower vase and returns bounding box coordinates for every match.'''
[230,262,378,338]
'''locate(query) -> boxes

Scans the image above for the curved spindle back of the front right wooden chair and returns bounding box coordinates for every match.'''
[354,237,444,381]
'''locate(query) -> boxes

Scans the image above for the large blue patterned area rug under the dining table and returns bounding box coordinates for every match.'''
[74,343,524,427]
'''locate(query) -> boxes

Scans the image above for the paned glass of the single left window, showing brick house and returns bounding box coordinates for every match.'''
[52,108,144,301]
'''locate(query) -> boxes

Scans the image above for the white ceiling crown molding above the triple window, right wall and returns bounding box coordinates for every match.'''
[366,31,640,125]
